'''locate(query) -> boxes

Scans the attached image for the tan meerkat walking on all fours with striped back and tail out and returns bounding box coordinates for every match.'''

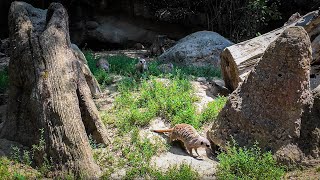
[152,124,211,157]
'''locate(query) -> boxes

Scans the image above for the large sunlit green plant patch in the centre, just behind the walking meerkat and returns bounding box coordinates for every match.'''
[111,76,200,131]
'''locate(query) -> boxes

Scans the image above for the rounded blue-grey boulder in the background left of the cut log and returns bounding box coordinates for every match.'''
[159,31,233,68]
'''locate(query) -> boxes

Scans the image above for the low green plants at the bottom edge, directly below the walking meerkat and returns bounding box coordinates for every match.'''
[153,164,200,180]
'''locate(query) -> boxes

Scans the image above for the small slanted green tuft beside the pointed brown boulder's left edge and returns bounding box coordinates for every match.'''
[200,96,228,123]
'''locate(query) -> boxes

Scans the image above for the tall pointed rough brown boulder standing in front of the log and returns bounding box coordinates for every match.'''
[208,27,313,166]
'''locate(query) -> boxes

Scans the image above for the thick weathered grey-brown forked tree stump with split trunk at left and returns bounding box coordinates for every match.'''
[0,2,107,177]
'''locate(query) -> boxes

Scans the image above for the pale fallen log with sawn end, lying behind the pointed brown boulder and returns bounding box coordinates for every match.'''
[220,11,320,91]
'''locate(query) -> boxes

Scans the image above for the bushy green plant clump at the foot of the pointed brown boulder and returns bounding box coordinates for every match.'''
[217,143,284,179]
